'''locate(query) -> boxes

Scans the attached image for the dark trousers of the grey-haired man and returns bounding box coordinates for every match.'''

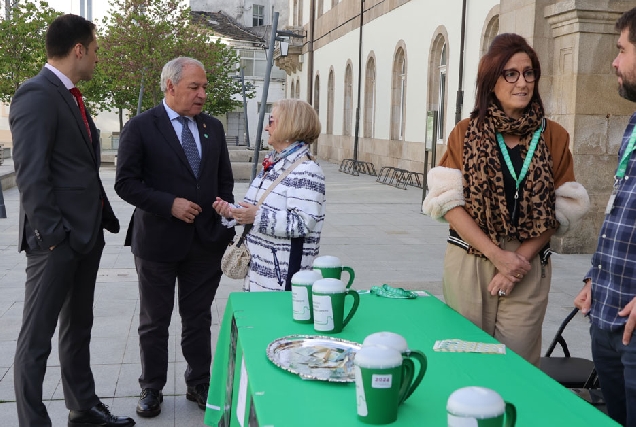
[135,238,223,390]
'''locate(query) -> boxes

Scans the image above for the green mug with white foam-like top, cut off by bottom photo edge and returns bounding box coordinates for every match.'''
[446,387,517,427]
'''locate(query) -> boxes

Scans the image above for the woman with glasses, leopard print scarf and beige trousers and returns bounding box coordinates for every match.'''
[423,34,589,365]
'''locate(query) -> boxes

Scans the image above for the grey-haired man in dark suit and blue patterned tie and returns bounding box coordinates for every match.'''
[115,57,234,417]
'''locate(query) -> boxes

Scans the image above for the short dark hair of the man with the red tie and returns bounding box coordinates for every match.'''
[46,13,95,58]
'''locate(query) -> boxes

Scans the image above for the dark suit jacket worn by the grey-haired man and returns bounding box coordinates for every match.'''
[115,104,234,262]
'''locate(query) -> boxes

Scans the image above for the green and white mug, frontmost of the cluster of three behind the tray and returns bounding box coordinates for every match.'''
[311,279,360,334]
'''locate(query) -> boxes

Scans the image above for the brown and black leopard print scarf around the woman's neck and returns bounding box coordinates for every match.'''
[463,102,557,255]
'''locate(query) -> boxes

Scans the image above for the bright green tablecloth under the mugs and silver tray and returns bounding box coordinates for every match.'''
[205,292,618,427]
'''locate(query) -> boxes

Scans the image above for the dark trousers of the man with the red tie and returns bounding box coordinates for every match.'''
[14,234,104,427]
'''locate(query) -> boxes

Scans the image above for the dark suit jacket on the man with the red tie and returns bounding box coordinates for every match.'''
[9,68,119,253]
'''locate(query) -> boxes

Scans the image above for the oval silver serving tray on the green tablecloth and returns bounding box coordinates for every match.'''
[267,335,362,383]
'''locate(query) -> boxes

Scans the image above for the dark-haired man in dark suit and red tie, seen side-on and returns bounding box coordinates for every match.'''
[9,15,135,427]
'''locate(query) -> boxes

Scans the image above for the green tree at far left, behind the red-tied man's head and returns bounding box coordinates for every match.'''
[0,0,60,103]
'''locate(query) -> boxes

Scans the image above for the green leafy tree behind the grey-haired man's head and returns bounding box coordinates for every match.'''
[82,0,246,130]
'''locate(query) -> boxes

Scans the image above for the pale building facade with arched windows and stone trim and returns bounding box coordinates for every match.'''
[278,0,634,253]
